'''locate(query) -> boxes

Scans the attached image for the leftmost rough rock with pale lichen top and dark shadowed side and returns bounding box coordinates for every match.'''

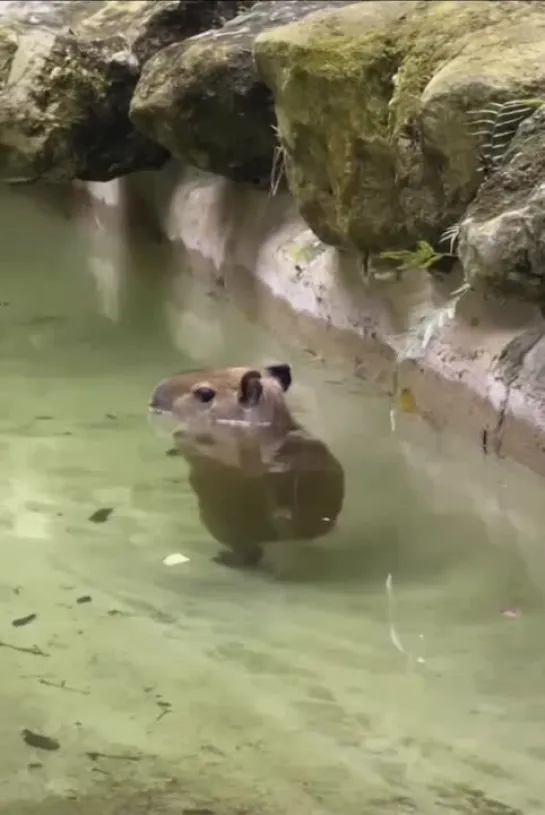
[0,25,168,181]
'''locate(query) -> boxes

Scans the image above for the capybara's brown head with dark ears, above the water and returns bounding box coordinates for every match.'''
[149,363,294,433]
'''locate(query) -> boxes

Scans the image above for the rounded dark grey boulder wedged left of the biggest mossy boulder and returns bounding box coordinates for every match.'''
[130,0,354,184]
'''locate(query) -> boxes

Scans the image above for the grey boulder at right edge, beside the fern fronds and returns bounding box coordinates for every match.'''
[458,103,545,306]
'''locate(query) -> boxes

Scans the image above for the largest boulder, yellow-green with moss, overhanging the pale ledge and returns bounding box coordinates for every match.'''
[254,0,545,254]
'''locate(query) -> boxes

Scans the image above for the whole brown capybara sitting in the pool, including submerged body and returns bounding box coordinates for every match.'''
[149,364,344,566]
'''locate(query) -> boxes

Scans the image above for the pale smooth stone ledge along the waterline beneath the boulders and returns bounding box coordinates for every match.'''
[81,165,545,482]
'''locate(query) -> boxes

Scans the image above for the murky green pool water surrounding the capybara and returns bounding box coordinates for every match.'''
[0,185,545,815]
